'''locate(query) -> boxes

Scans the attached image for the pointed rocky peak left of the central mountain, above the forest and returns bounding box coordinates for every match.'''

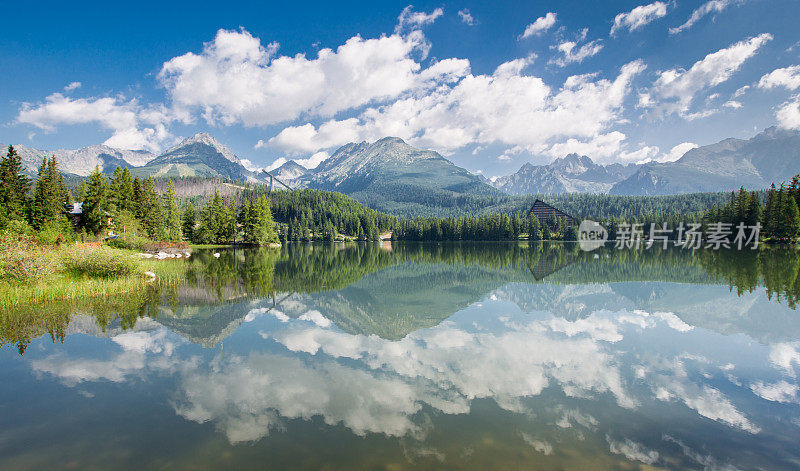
[131,133,261,181]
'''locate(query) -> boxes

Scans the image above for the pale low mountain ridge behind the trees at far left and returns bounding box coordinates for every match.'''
[0,144,155,177]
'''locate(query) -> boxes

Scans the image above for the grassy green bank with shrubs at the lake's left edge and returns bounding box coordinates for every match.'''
[0,238,185,312]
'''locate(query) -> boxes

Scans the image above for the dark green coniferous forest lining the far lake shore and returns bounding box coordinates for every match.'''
[0,146,800,248]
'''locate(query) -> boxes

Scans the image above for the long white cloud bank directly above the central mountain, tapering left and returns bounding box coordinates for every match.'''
[268,59,644,156]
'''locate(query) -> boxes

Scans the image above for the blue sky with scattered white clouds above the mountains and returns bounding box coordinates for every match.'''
[0,0,800,176]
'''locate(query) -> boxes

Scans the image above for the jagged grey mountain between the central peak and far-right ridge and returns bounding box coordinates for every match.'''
[492,154,636,195]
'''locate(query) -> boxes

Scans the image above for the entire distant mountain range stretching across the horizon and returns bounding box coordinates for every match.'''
[9,128,800,210]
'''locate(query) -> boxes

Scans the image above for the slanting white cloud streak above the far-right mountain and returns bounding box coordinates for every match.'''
[639,33,772,118]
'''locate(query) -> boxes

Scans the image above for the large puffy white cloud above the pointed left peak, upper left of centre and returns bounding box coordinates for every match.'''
[158,28,468,126]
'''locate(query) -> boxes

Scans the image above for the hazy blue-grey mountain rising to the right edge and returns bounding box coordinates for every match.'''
[610,127,800,195]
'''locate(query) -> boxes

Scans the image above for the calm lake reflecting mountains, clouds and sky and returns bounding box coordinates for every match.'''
[0,243,800,470]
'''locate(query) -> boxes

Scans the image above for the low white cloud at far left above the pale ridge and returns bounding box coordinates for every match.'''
[16,93,176,152]
